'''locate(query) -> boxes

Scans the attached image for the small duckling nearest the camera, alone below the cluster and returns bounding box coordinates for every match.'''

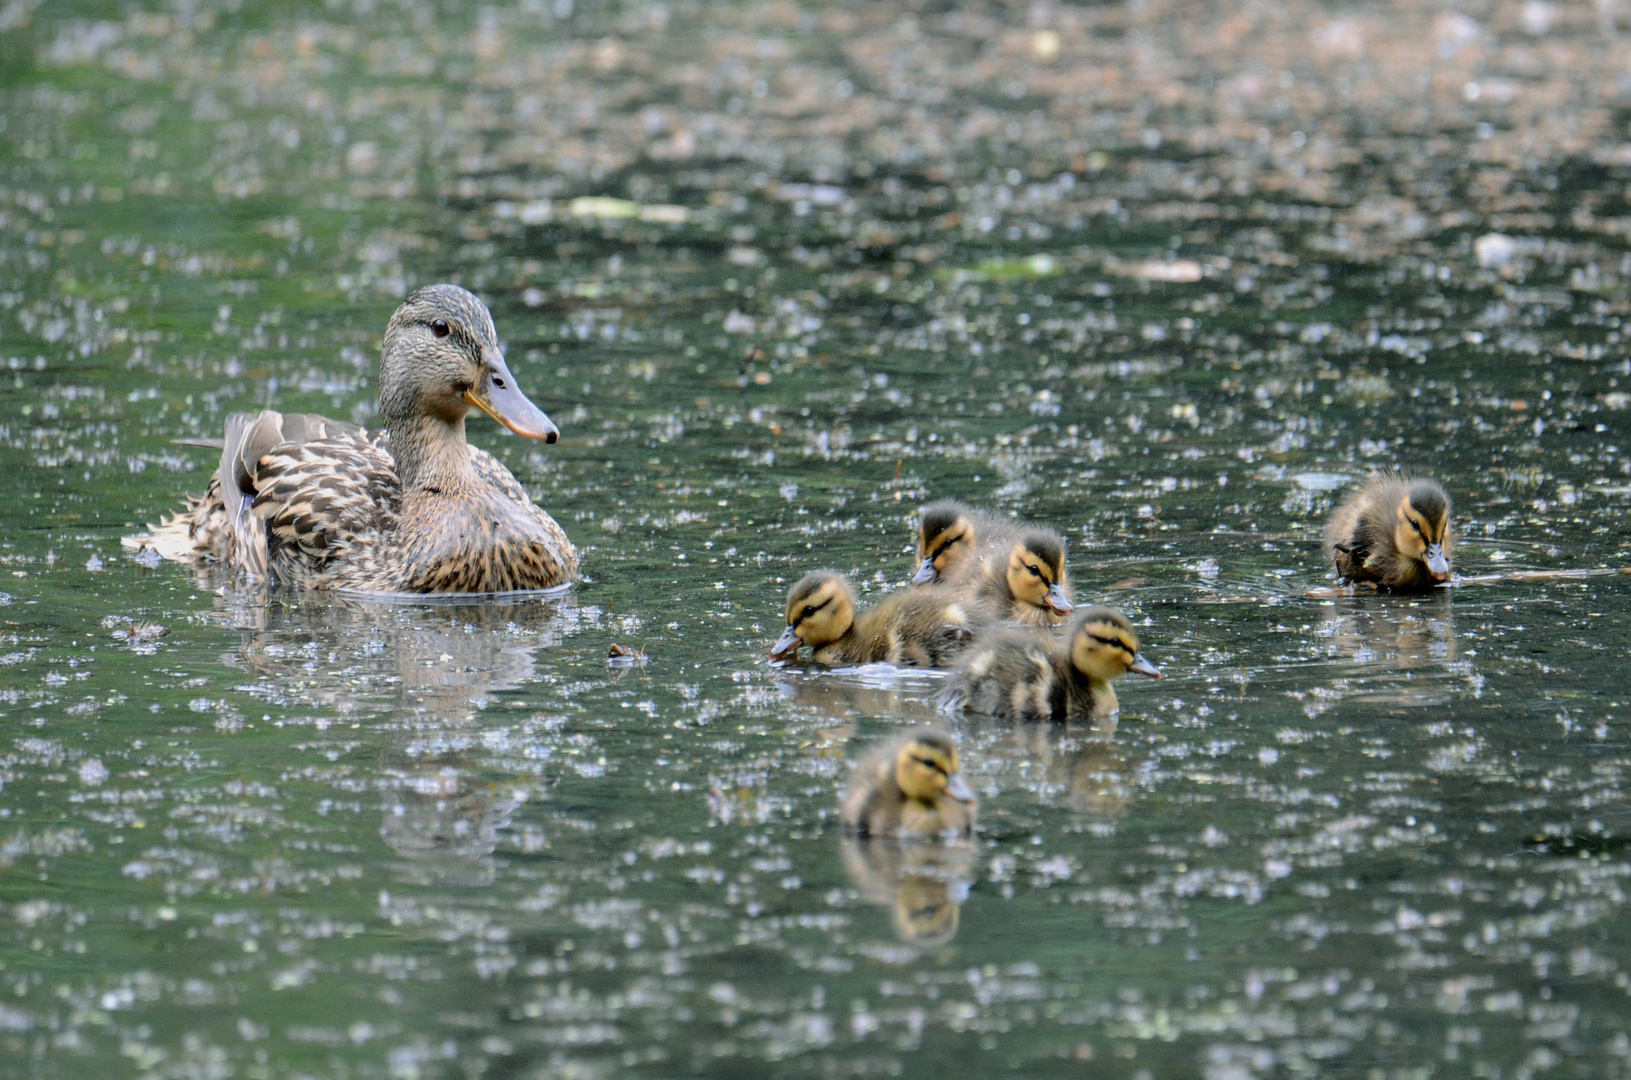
[838,728,975,839]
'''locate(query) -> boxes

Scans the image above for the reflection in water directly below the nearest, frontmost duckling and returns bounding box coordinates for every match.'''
[840,837,977,948]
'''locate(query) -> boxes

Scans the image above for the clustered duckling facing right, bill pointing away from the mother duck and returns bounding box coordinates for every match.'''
[941,607,1161,721]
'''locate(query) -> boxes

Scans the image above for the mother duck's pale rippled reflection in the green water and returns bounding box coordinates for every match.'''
[217,592,577,884]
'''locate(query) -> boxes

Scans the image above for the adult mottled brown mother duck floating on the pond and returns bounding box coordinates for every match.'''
[126,285,577,592]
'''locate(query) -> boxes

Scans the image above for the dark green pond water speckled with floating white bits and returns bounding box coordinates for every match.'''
[0,0,1631,1080]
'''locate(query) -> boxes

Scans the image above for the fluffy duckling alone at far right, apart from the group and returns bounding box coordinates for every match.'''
[1326,473,1450,591]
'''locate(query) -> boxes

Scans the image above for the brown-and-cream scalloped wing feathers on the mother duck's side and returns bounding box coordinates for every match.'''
[253,418,401,569]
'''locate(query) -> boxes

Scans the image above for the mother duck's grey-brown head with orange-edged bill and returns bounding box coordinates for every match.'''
[380,285,561,442]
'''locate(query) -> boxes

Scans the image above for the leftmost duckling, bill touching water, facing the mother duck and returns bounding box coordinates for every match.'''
[770,569,974,667]
